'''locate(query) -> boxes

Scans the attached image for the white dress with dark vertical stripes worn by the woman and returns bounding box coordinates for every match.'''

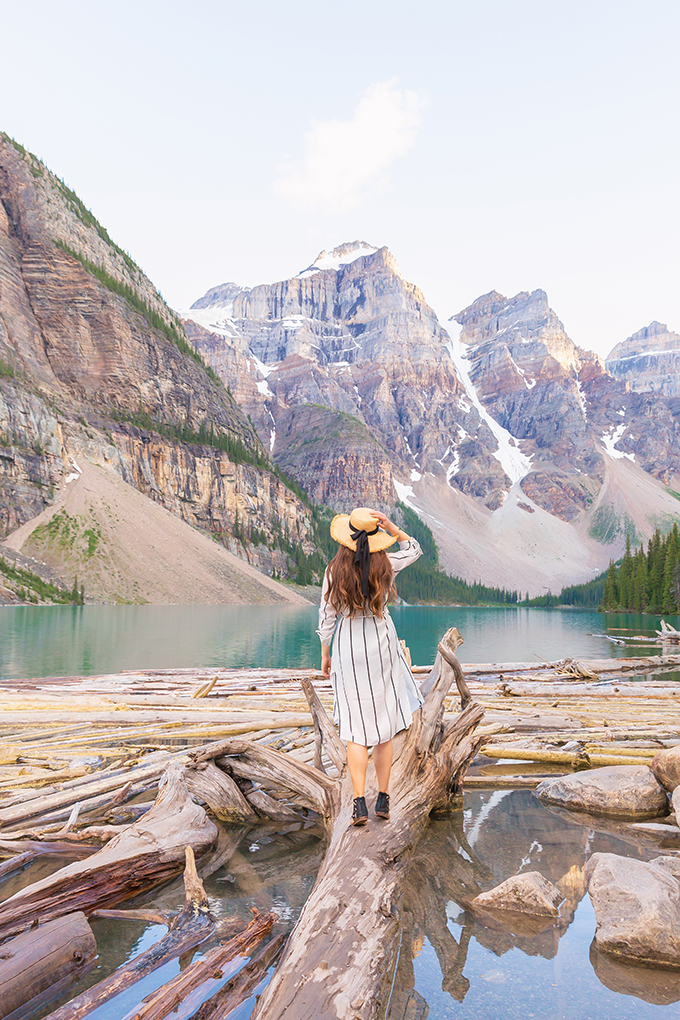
[316,539,423,748]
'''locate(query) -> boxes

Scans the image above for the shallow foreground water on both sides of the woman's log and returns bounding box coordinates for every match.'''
[27,789,680,1020]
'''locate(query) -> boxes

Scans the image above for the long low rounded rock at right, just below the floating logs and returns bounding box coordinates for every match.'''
[535,765,668,819]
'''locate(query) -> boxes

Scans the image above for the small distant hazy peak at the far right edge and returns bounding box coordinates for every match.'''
[606,322,680,397]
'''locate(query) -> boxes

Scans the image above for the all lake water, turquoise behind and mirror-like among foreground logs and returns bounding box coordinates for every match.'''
[5,606,680,1020]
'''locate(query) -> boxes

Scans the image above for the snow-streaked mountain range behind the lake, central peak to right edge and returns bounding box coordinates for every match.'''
[187,242,680,592]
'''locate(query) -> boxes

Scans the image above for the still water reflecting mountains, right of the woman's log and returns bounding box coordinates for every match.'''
[387,791,680,1020]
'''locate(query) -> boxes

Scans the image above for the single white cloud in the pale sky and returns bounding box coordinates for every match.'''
[275,80,423,211]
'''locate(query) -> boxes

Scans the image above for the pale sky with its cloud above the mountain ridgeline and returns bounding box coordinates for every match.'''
[0,0,680,354]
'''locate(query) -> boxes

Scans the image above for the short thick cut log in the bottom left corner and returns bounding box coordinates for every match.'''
[0,913,97,1016]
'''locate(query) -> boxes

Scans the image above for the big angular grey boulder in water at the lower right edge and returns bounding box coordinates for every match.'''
[585,854,680,969]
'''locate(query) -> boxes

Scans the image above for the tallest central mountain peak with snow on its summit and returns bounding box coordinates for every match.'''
[188,242,509,507]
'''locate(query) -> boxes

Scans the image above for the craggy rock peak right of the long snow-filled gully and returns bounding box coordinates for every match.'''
[456,291,680,520]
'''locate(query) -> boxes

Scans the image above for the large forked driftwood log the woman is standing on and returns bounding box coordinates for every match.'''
[186,628,483,1020]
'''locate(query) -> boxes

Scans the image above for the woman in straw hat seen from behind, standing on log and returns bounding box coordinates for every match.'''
[317,507,422,825]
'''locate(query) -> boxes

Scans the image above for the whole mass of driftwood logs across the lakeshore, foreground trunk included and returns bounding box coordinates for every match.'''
[0,630,680,1020]
